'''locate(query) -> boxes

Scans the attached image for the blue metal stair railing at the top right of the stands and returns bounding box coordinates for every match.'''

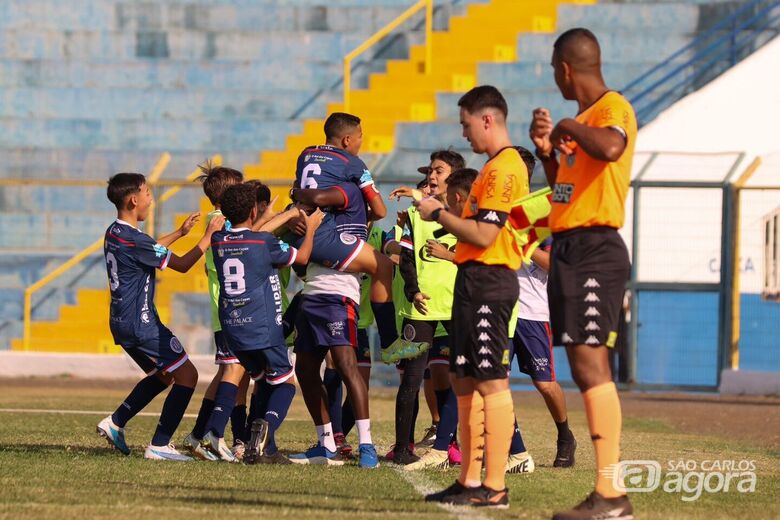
[622,0,780,126]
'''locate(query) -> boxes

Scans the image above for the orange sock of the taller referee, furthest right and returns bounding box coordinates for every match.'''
[582,383,623,498]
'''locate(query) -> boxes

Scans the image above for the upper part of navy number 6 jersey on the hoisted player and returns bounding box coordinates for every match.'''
[295,145,374,190]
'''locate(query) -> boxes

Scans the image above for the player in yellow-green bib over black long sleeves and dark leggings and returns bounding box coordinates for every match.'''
[390,150,465,471]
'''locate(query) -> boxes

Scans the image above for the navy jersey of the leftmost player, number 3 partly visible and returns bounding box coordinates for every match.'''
[103,220,171,345]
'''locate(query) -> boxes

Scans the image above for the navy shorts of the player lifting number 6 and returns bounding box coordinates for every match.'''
[295,294,359,352]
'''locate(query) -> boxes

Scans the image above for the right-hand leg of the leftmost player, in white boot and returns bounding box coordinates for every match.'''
[144,332,198,461]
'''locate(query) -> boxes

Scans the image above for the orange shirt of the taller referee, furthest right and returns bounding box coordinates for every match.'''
[550,91,637,233]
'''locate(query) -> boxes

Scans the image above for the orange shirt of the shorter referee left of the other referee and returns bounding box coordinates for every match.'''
[455,147,529,270]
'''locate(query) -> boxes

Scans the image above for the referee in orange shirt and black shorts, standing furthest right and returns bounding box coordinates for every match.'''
[530,28,637,520]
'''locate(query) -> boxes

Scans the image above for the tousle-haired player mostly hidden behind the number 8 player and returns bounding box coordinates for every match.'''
[184,163,246,460]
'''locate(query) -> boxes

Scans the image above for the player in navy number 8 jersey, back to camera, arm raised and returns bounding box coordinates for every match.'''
[209,184,323,464]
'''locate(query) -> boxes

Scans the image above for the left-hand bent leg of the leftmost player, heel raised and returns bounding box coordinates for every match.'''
[97,347,173,455]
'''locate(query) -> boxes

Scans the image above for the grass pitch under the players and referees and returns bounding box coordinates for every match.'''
[0,378,780,520]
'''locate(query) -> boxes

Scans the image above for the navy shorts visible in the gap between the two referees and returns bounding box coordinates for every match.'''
[509,318,555,382]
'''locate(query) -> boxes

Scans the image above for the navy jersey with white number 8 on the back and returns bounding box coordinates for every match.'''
[211,228,298,351]
